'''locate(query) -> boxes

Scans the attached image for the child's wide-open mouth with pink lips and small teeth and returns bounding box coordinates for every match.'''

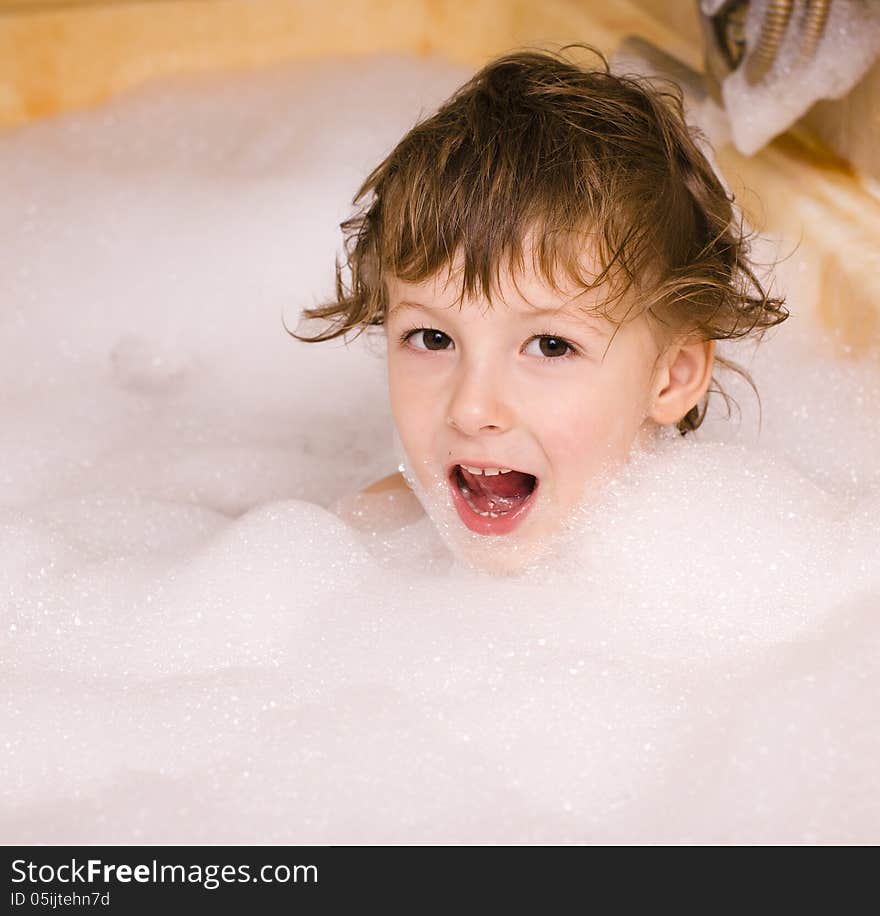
[449,464,538,534]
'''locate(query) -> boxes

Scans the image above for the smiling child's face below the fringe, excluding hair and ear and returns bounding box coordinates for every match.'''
[386,260,659,572]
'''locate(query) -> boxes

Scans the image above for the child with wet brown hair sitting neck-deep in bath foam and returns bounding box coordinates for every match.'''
[292,52,788,571]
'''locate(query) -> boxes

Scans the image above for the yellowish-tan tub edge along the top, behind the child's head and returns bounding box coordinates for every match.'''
[0,0,699,124]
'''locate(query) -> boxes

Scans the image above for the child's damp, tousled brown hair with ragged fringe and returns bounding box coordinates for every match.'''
[293,46,788,434]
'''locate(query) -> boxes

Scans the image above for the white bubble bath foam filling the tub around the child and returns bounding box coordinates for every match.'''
[0,58,880,843]
